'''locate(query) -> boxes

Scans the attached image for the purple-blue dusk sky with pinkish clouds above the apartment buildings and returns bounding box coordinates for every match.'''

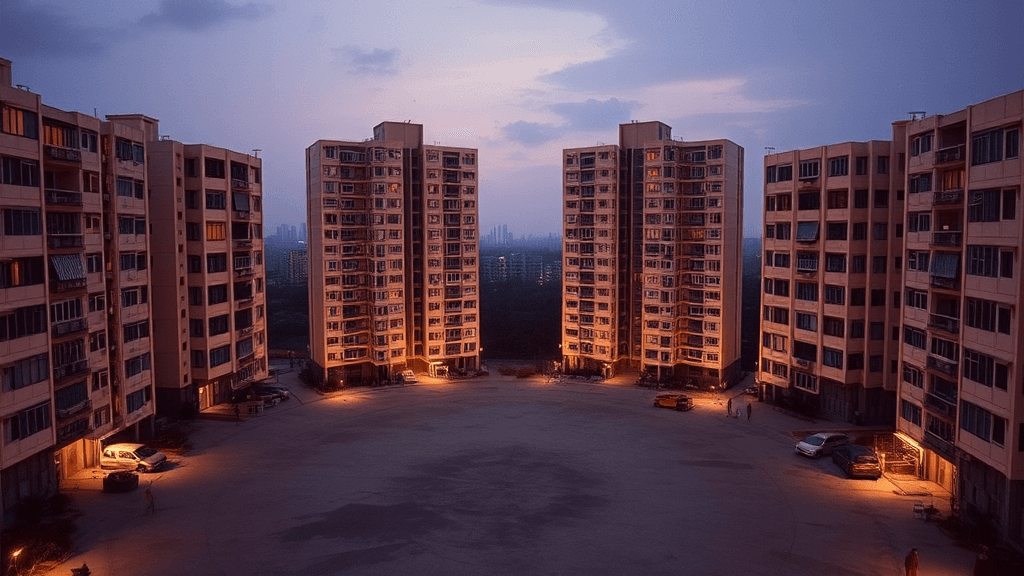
[0,0,1024,236]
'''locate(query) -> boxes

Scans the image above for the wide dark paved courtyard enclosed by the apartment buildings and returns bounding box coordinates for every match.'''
[52,366,973,576]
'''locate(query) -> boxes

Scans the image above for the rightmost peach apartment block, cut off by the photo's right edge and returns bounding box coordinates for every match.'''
[896,91,1024,548]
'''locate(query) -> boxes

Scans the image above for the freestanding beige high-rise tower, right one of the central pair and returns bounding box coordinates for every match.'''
[561,122,743,386]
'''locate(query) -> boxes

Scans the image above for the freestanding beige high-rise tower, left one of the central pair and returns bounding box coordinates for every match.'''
[306,122,480,383]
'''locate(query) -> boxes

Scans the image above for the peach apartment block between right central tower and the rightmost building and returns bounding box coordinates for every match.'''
[758,134,905,422]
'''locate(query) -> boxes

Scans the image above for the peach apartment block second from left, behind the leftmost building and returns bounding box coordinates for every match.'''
[144,132,267,416]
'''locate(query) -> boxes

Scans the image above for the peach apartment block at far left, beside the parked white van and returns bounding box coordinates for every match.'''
[0,59,154,521]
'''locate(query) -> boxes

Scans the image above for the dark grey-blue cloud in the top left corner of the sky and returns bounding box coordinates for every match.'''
[0,0,123,58]
